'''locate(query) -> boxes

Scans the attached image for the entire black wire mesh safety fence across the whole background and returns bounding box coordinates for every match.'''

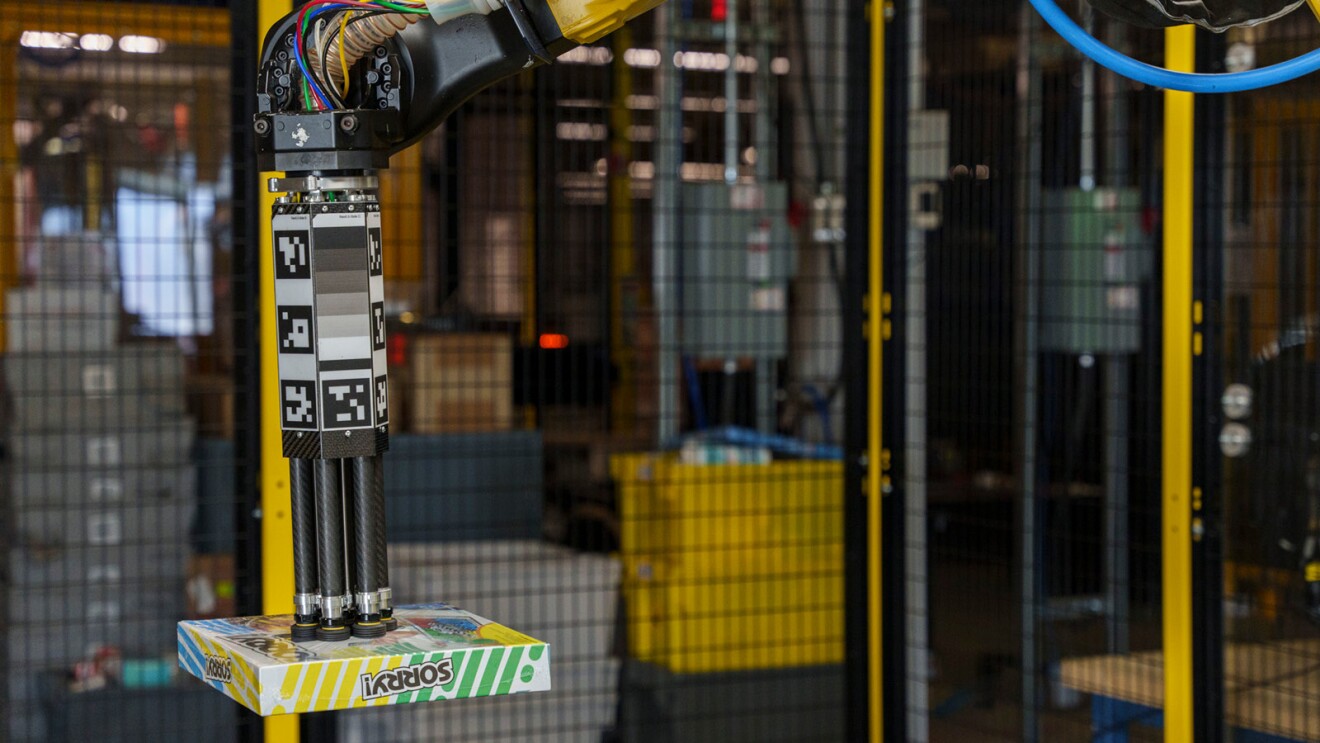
[10,0,1320,742]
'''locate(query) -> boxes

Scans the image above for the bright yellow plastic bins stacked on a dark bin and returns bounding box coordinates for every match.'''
[610,454,843,673]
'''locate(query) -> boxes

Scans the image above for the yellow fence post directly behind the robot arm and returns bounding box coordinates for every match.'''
[249,0,298,743]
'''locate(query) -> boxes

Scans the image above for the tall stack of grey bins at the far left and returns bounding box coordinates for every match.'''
[0,261,197,742]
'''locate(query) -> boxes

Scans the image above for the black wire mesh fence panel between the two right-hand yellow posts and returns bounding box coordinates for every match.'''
[902,1,1163,740]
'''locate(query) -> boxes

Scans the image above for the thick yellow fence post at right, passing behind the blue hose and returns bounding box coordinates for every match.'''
[1162,25,1196,743]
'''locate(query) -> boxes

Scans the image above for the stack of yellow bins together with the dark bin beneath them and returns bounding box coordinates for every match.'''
[611,453,845,743]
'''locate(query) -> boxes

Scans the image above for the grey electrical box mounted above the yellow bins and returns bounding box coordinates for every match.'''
[681,183,795,359]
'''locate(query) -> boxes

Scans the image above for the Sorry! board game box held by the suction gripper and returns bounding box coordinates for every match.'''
[178,603,550,717]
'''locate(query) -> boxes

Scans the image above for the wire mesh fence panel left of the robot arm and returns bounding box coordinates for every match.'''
[0,4,248,740]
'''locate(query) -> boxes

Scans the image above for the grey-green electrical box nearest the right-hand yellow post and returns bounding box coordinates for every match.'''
[1040,189,1152,354]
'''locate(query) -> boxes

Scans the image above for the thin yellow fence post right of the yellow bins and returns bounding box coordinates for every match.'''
[866,0,887,743]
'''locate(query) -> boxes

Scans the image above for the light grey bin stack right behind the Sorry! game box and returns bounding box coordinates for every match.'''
[339,540,620,743]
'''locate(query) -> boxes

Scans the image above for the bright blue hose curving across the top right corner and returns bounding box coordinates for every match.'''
[1031,0,1320,92]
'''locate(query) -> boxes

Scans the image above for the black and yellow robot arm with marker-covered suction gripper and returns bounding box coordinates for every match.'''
[252,0,660,641]
